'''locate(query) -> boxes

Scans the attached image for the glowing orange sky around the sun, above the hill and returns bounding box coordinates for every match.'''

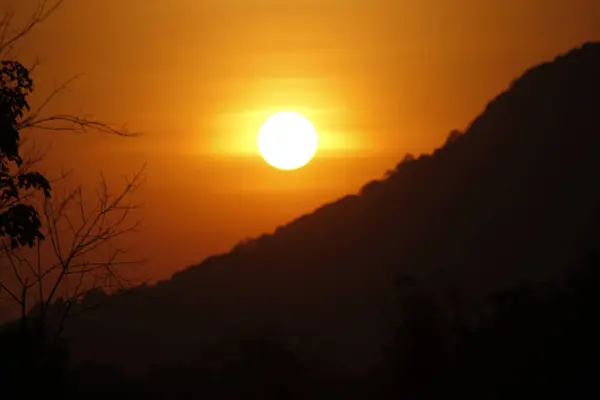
[8,0,600,278]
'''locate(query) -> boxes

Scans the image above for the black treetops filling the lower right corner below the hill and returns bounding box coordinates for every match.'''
[385,255,600,399]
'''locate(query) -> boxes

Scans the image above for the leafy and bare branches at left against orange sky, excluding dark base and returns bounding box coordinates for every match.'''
[0,0,141,317]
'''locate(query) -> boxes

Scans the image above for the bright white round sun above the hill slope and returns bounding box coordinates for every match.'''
[258,111,318,170]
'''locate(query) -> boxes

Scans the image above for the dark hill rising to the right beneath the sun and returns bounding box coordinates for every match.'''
[66,43,600,380]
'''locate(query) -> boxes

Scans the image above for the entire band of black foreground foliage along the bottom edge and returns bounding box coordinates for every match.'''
[11,255,600,399]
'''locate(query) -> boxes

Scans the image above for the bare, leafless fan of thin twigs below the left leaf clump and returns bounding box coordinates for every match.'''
[0,148,145,330]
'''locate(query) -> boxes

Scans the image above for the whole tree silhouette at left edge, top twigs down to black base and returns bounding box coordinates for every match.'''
[0,0,141,398]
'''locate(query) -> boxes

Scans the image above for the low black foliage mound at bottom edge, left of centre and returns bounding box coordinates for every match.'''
[65,335,317,399]
